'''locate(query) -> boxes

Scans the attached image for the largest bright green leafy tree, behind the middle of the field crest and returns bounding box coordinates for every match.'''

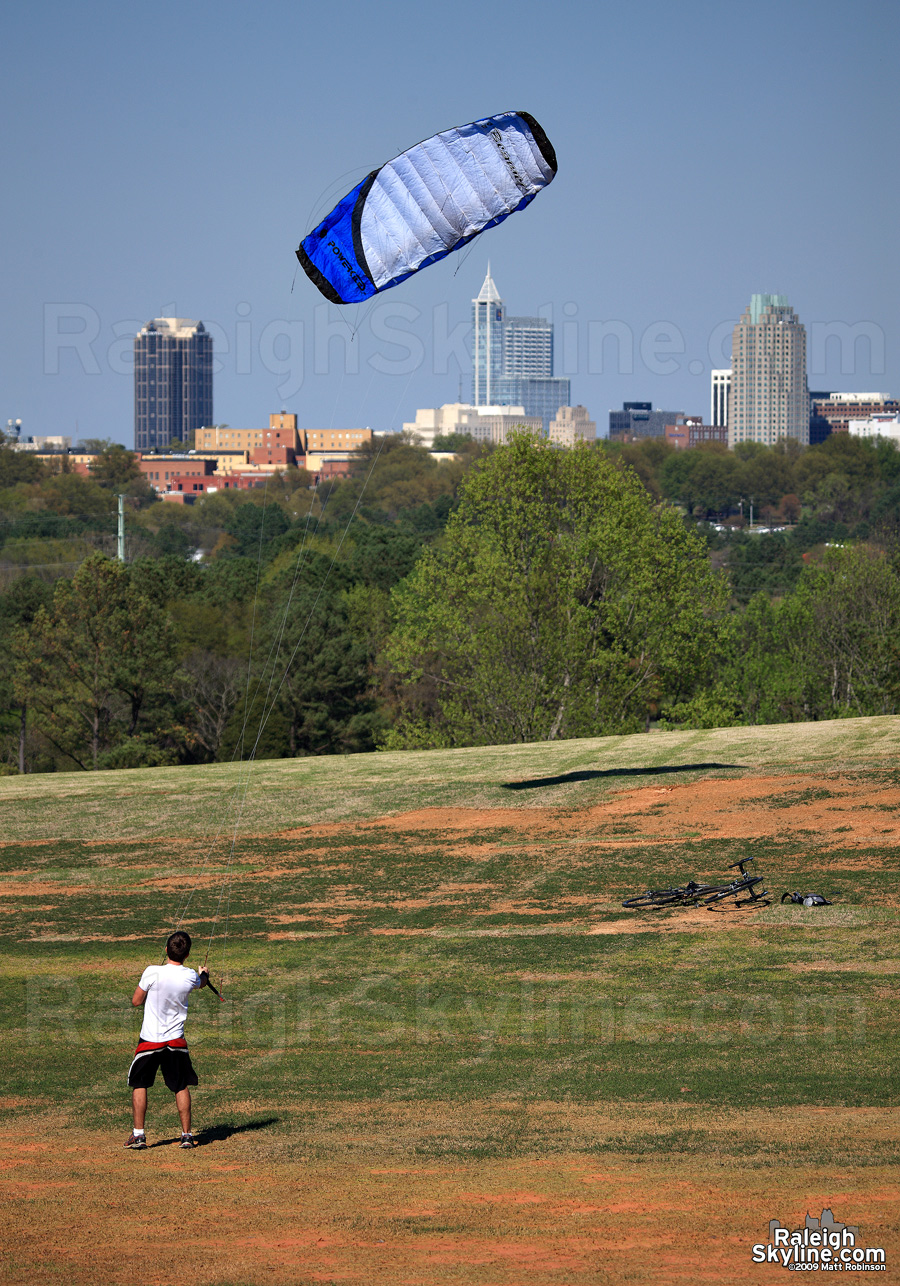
[387,433,725,745]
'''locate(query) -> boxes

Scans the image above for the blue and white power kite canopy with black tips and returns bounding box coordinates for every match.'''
[297,112,557,303]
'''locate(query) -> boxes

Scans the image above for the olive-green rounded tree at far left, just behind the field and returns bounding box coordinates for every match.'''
[13,554,175,768]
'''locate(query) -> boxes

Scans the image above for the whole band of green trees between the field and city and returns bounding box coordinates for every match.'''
[0,435,900,772]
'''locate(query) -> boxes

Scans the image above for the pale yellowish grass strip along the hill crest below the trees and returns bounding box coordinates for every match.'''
[0,716,900,842]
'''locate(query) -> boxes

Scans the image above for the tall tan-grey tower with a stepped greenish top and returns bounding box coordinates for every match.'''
[728,294,810,448]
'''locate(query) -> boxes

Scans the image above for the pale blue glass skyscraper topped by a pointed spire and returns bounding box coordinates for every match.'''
[472,264,571,432]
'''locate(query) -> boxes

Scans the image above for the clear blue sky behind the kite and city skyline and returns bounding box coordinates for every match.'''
[0,0,900,445]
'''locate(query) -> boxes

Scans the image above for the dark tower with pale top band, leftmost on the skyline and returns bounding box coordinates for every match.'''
[135,318,212,451]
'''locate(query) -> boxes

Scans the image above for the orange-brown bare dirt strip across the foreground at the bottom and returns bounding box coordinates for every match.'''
[0,1103,900,1286]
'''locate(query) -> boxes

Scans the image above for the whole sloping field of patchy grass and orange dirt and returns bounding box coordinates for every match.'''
[0,719,900,1286]
